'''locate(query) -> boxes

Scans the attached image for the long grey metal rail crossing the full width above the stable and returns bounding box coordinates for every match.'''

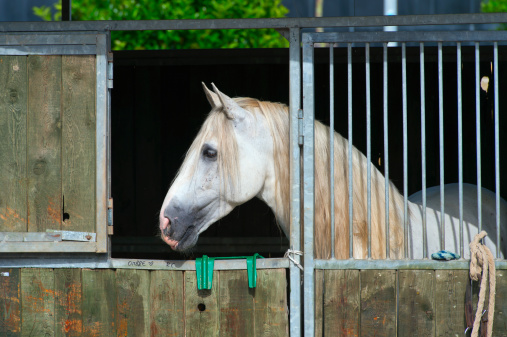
[0,13,507,32]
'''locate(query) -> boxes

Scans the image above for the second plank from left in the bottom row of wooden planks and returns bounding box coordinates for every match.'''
[21,268,55,336]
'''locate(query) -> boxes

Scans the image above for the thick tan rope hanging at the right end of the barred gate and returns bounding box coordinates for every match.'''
[470,231,496,337]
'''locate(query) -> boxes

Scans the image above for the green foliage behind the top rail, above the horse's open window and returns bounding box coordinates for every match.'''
[33,0,288,50]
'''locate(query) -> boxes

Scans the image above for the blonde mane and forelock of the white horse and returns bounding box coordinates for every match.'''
[180,97,403,259]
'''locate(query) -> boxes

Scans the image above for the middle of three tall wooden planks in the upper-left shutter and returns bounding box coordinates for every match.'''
[27,55,62,232]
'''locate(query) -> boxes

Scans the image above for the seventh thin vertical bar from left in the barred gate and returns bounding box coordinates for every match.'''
[438,42,446,251]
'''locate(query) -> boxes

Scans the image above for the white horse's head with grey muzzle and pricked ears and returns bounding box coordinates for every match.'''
[159,83,286,251]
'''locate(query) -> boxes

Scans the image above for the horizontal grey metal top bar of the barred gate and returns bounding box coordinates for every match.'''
[304,31,505,43]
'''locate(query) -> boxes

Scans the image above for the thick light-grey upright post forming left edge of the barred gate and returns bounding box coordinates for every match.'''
[303,34,315,337]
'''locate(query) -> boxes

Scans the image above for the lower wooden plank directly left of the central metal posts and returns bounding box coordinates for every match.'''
[254,269,289,336]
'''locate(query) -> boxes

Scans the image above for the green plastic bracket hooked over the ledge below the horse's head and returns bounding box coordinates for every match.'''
[195,253,264,290]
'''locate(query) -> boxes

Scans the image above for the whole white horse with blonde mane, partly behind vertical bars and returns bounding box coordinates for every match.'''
[160,84,507,259]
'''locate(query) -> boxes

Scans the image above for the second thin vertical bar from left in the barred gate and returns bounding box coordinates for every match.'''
[347,43,354,258]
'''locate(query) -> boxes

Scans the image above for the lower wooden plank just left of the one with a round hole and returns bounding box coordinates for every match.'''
[150,270,186,337]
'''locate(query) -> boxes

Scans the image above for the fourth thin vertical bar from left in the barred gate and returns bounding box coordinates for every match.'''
[383,42,391,259]
